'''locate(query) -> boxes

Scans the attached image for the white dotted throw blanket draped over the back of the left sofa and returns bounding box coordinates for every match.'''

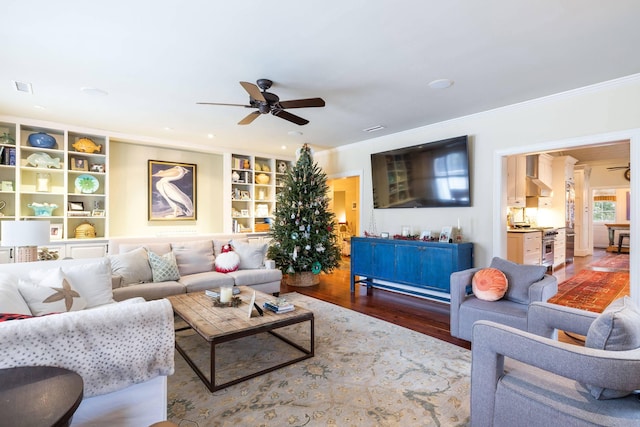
[0,300,175,397]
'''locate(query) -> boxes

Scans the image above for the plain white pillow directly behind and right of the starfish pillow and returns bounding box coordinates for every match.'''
[29,258,115,308]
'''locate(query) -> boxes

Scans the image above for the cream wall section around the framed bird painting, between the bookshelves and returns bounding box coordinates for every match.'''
[109,140,223,237]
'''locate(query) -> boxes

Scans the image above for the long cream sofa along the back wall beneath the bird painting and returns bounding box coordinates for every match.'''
[108,233,282,301]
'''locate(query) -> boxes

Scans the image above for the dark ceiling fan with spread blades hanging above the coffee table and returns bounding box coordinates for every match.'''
[197,79,325,126]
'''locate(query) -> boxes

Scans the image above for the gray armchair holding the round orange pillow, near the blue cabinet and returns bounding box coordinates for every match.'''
[450,257,558,341]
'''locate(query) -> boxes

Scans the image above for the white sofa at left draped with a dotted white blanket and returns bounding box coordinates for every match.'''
[0,258,174,427]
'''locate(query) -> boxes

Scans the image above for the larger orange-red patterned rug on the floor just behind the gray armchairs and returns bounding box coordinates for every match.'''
[549,270,630,313]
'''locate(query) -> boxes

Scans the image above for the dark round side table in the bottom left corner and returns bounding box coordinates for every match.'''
[0,366,84,427]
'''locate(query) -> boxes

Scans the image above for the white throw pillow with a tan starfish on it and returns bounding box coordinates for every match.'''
[18,268,87,316]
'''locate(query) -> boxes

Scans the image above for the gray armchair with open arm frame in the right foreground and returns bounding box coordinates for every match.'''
[471,302,640,427]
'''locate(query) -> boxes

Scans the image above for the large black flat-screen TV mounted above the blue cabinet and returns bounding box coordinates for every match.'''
[371,135,471,208]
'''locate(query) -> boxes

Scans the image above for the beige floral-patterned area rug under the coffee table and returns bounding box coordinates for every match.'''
[168,293,471,427]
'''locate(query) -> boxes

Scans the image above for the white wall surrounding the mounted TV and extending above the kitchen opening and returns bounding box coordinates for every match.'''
[315,76,640,266]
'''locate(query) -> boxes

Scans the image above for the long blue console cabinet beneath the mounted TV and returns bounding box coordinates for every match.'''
[351,237,473,301]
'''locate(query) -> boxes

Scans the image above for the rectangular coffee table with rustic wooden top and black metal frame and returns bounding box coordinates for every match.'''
[168,286,314,392]
